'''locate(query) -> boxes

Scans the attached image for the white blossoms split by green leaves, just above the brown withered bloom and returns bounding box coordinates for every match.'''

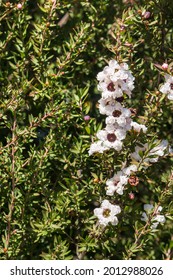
[131,140,169,163]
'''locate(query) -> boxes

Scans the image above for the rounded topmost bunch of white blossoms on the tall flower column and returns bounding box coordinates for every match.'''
[97,60,134,98]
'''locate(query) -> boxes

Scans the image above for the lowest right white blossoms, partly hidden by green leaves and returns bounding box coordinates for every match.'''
[141,204,166,229]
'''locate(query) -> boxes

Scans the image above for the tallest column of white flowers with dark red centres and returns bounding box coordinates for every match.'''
[89,60,147,155]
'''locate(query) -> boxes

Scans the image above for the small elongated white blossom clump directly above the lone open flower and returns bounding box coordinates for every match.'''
[106,165,137,196]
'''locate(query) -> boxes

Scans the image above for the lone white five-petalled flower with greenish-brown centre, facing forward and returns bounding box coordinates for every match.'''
[94,200,121,226]
